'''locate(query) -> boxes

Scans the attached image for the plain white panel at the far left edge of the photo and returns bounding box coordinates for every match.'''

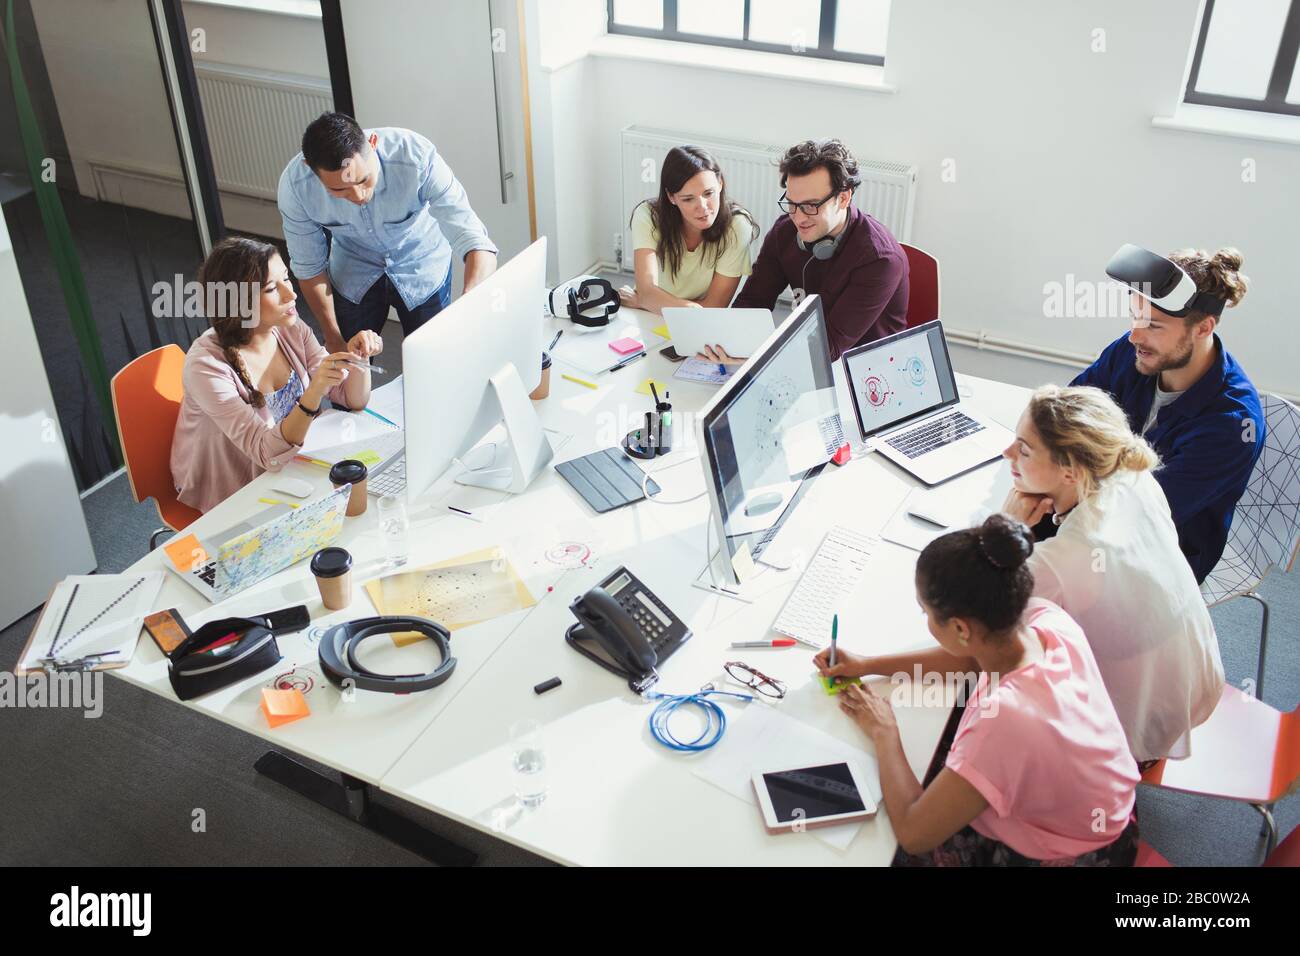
[0,204,95,628]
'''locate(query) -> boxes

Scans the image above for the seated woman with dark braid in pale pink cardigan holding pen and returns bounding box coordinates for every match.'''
[172,238,384,511]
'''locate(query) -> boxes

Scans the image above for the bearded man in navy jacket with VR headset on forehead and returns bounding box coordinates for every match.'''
[1070,245,1264,583]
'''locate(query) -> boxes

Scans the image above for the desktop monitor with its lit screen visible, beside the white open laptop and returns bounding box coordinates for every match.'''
[697,295,840,583]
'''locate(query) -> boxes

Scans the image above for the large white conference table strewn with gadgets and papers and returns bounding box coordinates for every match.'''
[109,310,1027,865]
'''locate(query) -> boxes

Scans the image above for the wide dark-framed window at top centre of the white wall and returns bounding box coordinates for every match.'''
[608,0,891,66]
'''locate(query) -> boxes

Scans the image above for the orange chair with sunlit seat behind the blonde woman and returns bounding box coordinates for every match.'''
[1141,684,1300,857]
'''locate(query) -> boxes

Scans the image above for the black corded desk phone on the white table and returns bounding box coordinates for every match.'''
[564,567,690,693]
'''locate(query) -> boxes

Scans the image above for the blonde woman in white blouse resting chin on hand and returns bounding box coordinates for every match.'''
[1002,385,1223,763]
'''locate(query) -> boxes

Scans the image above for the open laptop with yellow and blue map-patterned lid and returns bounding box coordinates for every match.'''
[165,485,352,604]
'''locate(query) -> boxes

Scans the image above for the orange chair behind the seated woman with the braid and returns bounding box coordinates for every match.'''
[112,345,200,551]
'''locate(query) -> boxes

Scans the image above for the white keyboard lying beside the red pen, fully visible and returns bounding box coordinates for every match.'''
[772,525,879,650]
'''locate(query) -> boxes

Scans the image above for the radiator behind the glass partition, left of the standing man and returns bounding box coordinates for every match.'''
[194,62,334,202]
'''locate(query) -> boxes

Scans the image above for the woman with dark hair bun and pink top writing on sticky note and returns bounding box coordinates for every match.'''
[816,515,1138,866]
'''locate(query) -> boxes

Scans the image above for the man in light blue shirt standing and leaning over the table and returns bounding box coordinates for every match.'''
[278,113,497,352]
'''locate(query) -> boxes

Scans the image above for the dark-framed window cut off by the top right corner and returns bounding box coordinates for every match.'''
[1184,0,1300,116]
